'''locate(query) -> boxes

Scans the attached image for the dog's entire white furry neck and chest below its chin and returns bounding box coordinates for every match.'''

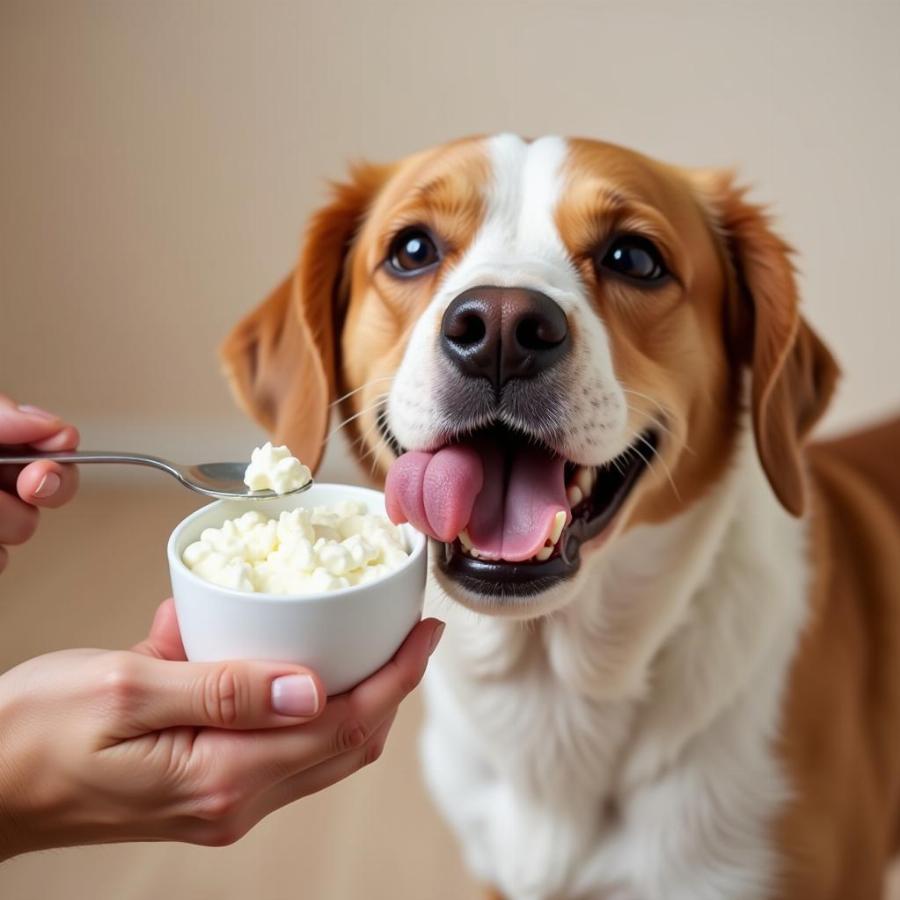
[423,458,806,900]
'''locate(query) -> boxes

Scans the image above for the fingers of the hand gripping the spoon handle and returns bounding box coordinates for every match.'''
[0,394,78,572]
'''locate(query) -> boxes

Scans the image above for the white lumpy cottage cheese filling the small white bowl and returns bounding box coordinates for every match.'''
[182,502,409,594]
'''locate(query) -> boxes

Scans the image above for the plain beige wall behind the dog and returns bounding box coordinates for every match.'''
[0,0,900,472]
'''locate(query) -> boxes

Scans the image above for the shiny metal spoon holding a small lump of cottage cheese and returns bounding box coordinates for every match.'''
[0,450,312,500]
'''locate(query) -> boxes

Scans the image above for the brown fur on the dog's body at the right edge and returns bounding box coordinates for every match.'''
[778,420,900,900]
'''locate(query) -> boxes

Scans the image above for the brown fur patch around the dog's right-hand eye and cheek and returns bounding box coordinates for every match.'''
[556,141,742,526]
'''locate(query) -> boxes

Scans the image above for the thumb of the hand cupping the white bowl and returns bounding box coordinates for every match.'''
[105,652,325,738]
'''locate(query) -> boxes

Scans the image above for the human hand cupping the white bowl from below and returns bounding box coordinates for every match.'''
[0,600,443,860]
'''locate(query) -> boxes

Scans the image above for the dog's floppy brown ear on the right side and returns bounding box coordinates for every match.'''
[693,172,840,516]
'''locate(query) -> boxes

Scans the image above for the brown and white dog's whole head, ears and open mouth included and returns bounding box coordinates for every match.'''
[225,135,836,615]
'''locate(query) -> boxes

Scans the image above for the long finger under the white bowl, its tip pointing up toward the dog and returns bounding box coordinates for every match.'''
[210,619,444,778]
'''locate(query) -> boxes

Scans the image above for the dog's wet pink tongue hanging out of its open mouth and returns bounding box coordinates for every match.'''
[385,441,569,562]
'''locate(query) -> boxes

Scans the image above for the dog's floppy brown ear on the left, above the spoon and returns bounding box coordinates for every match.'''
[220,164,389,468]
